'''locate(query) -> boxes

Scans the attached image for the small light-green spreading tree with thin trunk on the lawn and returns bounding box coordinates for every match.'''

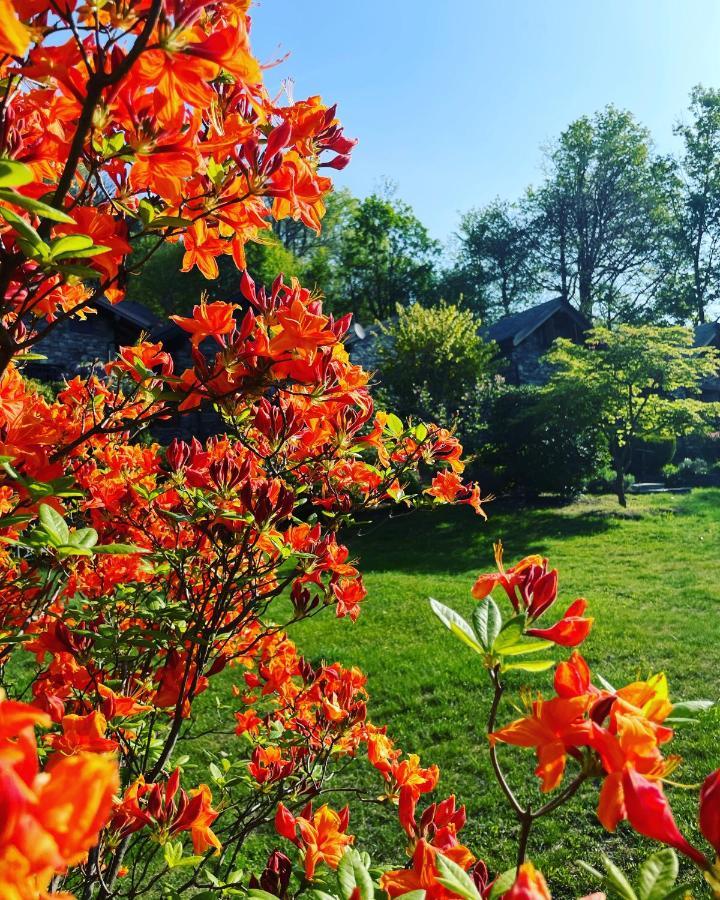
[547,325,720,506]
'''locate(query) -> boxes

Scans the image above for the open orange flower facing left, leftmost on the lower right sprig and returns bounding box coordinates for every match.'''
[489,695,593,791]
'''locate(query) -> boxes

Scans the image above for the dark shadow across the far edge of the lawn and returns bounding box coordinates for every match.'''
[347,501,616,574]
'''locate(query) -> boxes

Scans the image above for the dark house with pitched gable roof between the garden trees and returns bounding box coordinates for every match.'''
[483,297,592,385]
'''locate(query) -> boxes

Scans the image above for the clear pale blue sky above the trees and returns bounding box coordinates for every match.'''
[252,0,720,240]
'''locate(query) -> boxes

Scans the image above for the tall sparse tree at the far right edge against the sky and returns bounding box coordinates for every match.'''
[663,86,720,323]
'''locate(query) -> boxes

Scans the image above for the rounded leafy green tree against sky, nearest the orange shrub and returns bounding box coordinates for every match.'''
[335,194,440,320]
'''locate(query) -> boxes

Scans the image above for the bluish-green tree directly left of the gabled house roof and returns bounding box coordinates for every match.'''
[444,199,537,320]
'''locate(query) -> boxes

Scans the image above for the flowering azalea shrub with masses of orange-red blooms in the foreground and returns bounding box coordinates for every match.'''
[0,0,718,900]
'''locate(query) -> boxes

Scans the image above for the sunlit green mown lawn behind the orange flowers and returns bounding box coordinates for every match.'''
[194,490,720,898]
